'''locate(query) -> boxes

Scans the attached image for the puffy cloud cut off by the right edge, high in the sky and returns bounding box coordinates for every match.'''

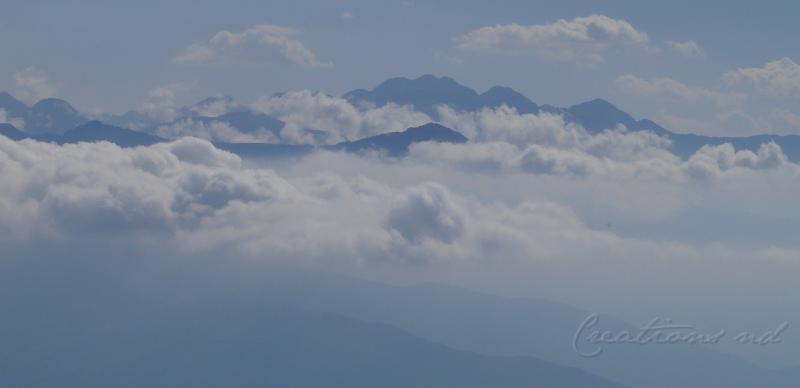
[723,58,800,96]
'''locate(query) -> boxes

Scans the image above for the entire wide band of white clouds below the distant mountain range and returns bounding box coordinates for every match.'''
[0,135,798,284]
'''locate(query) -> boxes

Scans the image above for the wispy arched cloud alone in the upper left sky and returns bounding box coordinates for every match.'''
[172,24,333,67]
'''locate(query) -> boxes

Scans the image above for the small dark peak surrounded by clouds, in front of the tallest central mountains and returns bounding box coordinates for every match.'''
[331,123,467,156]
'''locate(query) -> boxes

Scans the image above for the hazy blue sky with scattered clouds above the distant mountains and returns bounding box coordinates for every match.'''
[0,0,800,135]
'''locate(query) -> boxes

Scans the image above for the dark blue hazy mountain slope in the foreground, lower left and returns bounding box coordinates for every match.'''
[0,258,622,388]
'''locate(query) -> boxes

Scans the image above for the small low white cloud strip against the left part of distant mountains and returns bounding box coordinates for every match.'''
[155,117,280,143]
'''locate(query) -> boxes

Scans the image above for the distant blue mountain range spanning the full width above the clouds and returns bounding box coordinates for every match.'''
[0,75,800,162]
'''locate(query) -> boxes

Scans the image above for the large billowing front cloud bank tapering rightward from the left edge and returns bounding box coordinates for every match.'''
[0,134,680,265]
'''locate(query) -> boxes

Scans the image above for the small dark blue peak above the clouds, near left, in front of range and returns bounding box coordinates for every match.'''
[57,121,165,147]
